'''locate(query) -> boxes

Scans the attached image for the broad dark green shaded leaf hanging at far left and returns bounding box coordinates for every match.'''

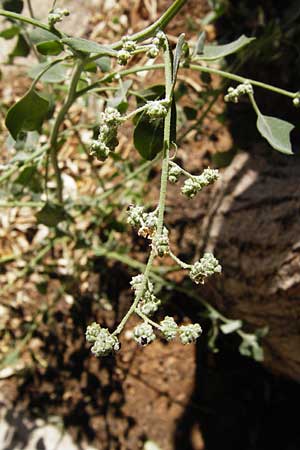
[5,91,49,140]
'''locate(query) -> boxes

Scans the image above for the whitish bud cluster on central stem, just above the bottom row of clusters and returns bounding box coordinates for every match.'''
[130,274,161,316]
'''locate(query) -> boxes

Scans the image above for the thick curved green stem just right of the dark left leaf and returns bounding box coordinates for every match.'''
[50,59,85,203]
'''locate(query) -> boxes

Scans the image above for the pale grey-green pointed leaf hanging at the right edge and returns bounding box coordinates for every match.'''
[256,112,295,155]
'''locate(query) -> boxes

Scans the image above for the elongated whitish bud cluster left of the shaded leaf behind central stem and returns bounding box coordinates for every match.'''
[90,107,122,161]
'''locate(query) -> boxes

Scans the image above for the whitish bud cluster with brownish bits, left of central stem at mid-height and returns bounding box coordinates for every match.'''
[127,206,157,239]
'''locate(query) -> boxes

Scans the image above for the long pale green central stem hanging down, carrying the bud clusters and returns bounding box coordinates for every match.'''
[113,39,172,336]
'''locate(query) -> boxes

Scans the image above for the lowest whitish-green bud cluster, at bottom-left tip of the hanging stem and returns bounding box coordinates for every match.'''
[85,322,120,356]
